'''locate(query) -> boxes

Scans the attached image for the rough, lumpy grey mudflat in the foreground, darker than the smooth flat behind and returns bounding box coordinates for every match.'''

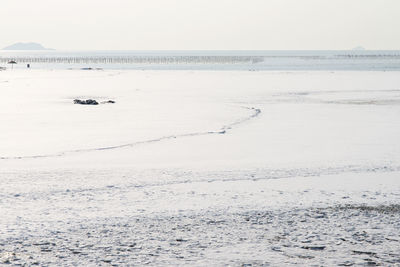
[0,205,400,266]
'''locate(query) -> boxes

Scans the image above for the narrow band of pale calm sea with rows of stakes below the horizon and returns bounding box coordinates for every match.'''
[0,50,400,71]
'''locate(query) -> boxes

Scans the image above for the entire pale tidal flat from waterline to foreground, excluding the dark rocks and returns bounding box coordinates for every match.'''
[0,69,400,266]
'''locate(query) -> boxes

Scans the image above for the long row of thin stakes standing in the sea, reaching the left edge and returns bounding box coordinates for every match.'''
[0,56,264,64]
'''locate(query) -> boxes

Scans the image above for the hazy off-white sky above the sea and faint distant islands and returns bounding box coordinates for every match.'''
[0,0,400,50]
